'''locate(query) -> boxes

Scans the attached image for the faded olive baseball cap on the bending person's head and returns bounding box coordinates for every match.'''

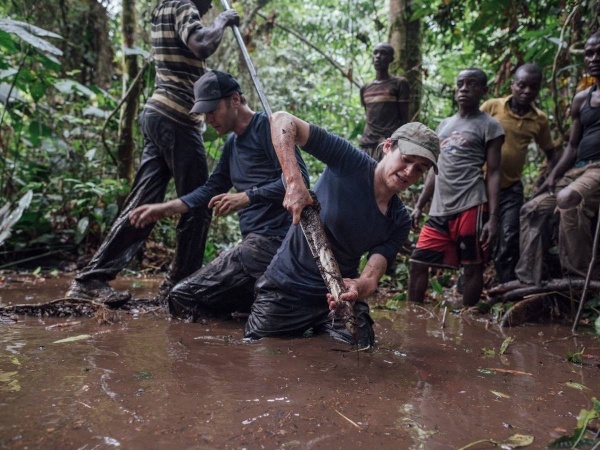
[390,122,440,175]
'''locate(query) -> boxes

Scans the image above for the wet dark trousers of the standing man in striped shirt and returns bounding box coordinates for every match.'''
[75,108,211,283]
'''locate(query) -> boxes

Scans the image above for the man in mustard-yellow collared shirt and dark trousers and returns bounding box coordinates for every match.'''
[481,64,556,283]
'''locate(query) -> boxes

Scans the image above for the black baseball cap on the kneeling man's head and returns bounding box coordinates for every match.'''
[190,70,242,114]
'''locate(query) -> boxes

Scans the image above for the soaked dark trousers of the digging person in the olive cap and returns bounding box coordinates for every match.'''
[245,276,375,347]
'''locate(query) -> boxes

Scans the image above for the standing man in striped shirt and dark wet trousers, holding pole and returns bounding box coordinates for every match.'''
[66,0,239,300]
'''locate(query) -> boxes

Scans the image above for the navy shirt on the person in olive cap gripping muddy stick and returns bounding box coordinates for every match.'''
[265,125,411,296]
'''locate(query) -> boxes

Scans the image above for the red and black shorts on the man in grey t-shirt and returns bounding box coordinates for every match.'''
[410,204,489,269]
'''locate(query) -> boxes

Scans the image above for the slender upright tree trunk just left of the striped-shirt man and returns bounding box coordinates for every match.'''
[117,0,142,183]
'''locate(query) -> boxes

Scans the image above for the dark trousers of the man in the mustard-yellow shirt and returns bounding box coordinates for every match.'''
[493,181,523,283]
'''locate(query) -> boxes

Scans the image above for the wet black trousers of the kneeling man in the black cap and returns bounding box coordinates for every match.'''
[168,233,282,321]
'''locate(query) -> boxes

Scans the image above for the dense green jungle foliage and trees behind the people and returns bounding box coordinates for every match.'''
[0,0,600,269]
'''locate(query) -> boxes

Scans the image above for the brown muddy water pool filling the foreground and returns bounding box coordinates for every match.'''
[0,280,600,450]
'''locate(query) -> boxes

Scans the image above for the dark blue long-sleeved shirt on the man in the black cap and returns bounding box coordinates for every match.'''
[181,113,308,237]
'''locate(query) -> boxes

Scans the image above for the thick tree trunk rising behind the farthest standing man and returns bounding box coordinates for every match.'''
[389,0,423,121]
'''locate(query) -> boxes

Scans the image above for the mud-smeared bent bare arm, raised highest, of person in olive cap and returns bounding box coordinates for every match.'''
[270,111,313,224]
